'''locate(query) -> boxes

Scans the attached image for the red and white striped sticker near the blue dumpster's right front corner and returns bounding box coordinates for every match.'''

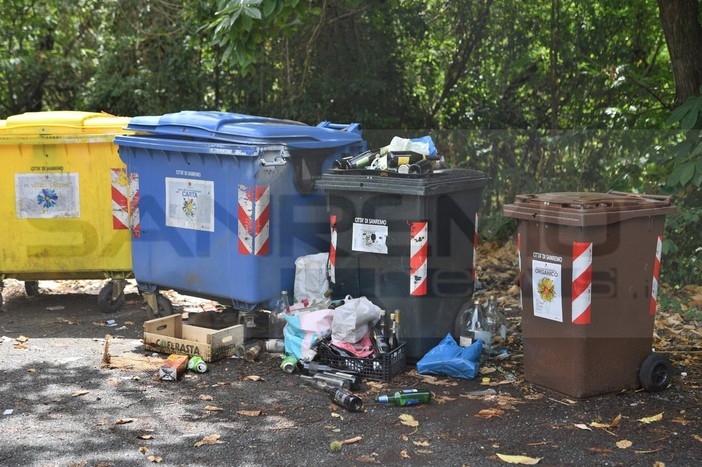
[238,185,271,256]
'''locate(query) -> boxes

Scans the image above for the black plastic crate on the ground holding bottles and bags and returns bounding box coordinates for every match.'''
[318,342,407,381]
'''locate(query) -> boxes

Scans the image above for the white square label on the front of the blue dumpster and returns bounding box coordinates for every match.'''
[166,177,214,232]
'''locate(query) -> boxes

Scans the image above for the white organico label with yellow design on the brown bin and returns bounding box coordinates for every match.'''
[531,260,563,323]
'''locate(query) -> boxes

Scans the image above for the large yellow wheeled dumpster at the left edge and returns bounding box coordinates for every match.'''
[0,111,133,312]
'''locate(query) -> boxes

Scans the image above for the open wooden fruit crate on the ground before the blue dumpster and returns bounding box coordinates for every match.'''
[144,314,244,362]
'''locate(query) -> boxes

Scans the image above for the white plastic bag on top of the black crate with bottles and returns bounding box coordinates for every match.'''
[332,296,380,344]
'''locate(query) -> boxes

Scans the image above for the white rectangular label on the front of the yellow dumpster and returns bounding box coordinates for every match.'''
[15,173,80,219]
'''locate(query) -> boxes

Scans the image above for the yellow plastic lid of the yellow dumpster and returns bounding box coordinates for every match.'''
[0,110,133,136]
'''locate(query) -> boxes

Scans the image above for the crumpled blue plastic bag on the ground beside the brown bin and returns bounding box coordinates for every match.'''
[417,333,483,379]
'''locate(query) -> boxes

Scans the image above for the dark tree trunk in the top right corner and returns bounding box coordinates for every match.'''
[658,0,702,104]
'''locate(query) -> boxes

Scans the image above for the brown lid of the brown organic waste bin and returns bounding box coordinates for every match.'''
[503,191,676,226]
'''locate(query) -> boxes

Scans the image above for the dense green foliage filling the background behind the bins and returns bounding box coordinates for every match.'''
[0,0,702,283]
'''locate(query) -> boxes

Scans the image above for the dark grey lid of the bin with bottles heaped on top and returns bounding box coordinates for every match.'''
[315,169,486,196]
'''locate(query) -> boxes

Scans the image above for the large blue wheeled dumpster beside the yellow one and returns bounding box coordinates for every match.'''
[115,111,365,315]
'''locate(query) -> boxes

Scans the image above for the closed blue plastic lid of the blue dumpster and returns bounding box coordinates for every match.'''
[127,111,362,149]
